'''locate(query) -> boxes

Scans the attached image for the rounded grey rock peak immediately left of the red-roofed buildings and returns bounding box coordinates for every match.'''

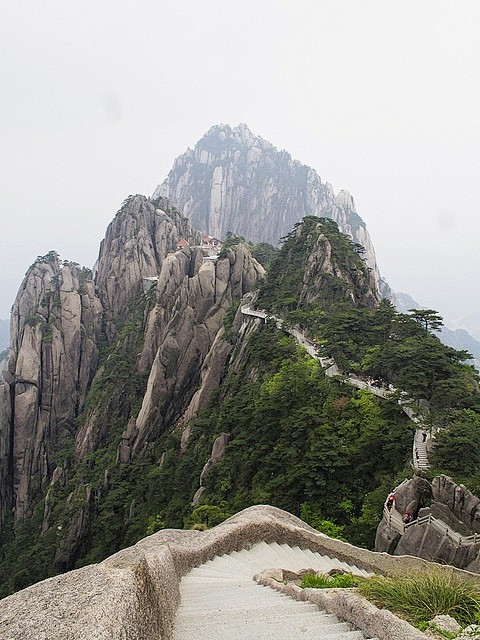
[95,195,201,317]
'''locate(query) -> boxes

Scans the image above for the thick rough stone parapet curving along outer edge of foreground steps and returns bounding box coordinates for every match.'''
[0,506,473,640]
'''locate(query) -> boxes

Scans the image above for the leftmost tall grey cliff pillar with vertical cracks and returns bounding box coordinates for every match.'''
[0,252,101,519]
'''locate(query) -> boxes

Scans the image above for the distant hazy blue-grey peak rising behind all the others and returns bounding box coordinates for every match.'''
[154,124,391,297]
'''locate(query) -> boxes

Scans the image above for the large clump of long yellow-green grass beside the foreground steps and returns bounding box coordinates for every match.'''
[360,570,480,625]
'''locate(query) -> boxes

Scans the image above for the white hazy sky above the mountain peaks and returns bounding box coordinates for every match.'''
[0,0,480,330]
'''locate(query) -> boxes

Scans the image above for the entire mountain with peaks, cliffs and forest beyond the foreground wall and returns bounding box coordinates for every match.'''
[0,125,480,596]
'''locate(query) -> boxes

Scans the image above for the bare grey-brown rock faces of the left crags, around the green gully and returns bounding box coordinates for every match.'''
[0,196,264,570]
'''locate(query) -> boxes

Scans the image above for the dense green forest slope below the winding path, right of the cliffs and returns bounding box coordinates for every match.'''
[180,323,412,545]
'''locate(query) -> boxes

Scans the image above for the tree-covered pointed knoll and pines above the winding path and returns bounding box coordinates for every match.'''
[259,217,480,412]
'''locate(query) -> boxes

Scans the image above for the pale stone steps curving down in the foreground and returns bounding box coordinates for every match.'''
[173,542,375,640]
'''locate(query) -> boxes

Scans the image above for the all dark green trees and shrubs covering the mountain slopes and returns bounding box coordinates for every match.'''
[0,218,480,595]
